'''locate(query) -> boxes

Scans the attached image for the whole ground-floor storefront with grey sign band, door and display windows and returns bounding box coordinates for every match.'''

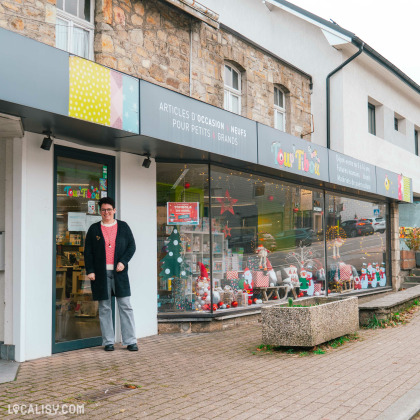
[0,29,413,361]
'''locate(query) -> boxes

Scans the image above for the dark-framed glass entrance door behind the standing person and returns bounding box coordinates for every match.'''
[52,146,115,353]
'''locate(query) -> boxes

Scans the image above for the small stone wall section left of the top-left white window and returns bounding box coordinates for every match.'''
[0,0,56,46]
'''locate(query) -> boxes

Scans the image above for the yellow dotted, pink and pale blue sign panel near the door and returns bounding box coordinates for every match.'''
[69,56,139,134]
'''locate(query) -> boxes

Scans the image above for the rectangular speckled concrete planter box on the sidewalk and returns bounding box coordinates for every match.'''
[261,297,359,347]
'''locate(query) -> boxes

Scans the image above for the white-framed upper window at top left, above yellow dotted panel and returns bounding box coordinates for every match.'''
[55,0,94,59]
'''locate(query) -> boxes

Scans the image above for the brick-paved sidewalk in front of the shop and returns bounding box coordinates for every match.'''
[0,313,420,420]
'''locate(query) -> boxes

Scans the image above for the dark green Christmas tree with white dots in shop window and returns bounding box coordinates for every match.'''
[159,226,191,309]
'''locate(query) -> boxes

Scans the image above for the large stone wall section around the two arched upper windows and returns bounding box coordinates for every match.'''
[95,0,311,140]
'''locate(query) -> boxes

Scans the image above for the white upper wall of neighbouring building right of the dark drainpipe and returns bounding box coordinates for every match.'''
[340,60,420,194]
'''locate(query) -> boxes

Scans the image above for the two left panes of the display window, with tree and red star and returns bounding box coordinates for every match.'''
[157,163,325,312]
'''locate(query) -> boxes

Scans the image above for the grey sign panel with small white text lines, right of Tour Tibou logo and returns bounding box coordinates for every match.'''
[328,150,376,193]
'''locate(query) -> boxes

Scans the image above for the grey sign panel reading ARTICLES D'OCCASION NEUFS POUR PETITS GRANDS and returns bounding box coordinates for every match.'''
[140,80,257,163]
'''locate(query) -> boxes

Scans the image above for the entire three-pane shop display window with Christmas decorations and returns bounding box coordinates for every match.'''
[157,163,389,312]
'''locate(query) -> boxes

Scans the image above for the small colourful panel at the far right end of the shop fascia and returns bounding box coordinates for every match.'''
[376,167,413,203]
